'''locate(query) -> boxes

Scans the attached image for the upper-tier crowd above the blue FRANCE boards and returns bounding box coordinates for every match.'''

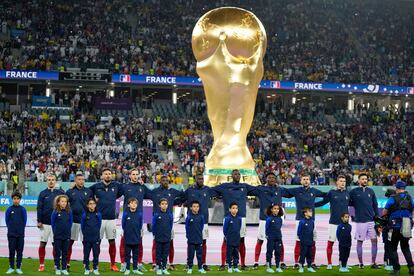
[0,0,414,86]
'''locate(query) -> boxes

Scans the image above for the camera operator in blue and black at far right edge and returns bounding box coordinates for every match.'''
[384,181,414,275]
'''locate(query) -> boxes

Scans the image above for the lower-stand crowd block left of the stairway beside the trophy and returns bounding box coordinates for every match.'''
[0,112,182,183]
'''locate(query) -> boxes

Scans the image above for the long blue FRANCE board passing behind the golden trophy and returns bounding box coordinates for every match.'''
[112,74,414,95]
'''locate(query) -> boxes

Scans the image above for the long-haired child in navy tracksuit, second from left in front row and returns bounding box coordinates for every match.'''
[50,195,73,275]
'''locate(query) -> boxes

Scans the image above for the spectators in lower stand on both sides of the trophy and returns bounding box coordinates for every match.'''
[0,96,414,185]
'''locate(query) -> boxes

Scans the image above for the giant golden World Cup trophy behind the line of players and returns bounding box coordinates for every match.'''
[192,7,267,186]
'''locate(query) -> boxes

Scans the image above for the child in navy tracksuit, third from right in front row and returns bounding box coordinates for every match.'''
[265,204,283,273]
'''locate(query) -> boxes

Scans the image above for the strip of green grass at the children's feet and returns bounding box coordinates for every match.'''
[0,258,408,276]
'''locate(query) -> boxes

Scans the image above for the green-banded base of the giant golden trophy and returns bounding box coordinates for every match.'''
[204,169,261,187]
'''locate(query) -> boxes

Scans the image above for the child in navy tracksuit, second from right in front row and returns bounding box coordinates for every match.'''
[297,207,316,273]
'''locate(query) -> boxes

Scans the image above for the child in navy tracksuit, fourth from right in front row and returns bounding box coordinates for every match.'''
[223,202,242,273]
